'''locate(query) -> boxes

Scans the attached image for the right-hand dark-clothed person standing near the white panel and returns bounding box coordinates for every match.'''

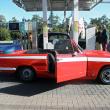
[101,29,107,51]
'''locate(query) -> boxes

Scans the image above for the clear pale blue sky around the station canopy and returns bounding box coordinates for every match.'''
[0,0,110,23]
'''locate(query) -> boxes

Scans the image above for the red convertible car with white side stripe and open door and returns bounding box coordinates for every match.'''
[0,33,110,84]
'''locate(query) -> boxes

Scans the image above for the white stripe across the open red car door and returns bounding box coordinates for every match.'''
[57,57,87,62]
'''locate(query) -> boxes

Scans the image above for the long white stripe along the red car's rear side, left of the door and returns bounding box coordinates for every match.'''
[0,56,47,59]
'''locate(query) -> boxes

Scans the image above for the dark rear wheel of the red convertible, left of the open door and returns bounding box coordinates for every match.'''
[18,67,35,82]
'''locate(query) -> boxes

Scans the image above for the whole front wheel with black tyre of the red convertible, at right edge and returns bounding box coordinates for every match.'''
[99,67,110,84]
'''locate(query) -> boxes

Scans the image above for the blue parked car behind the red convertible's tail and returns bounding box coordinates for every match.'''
[0,41,22,54]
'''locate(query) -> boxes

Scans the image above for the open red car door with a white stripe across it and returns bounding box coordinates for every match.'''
[56,39,87,83]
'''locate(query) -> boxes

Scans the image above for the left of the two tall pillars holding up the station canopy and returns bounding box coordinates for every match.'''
[42,0,48,49]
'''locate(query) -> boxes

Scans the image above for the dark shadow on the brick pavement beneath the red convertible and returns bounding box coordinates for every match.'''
[0,74,97,96]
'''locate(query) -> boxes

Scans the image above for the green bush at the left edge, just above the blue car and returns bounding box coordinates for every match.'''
[0,28,11,41]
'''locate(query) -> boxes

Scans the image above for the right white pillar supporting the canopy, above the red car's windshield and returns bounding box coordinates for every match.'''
[72,0,79,44]
